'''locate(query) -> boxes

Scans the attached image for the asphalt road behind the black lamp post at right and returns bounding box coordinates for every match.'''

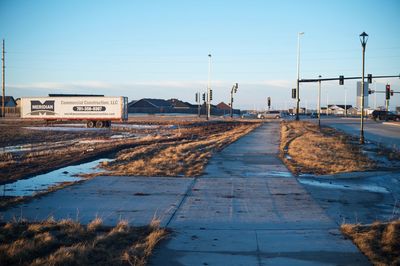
[311,118,400,151]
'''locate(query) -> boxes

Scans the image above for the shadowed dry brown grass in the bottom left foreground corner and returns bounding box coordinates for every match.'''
[0,219,167,265]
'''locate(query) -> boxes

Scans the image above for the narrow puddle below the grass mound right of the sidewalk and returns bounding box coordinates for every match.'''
[298,178,389,194]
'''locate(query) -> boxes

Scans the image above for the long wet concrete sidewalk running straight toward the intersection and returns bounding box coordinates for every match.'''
[150,123,369,265]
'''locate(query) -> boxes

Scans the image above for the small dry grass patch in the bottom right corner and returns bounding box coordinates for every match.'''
[341,220,400,265]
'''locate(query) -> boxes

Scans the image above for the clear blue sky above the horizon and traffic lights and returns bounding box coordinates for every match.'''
[0,0,400,109]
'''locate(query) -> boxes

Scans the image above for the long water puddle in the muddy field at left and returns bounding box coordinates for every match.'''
[0,159,111,197]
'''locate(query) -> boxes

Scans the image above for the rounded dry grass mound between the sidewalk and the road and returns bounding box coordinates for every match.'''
[281,121,375,174]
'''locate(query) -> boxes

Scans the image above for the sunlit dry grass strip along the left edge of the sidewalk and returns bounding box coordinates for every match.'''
[99,123,260,176]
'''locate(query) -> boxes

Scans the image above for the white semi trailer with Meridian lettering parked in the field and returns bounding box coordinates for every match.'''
[21,95,128,128]
